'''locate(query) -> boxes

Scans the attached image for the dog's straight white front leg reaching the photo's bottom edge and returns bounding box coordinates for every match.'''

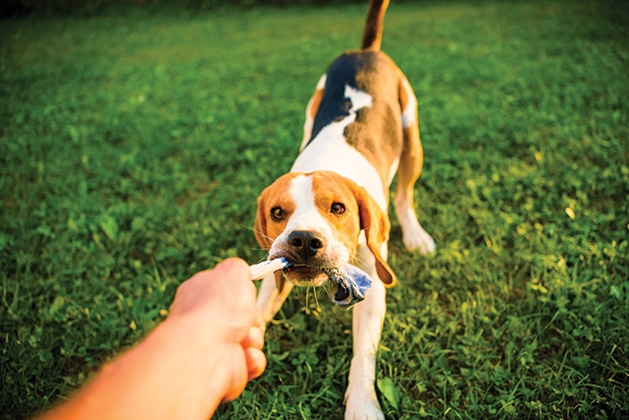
[345,270,386,420]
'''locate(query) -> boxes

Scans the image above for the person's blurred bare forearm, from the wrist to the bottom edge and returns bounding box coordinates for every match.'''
[38,320,231,420]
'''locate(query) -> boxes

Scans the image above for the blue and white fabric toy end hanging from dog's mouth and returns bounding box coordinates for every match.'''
[325,264,373,308]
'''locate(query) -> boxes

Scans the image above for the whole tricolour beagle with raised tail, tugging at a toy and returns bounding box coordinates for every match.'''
[255,0,435,419]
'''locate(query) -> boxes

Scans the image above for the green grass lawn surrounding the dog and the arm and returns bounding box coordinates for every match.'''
[0,0,629,419]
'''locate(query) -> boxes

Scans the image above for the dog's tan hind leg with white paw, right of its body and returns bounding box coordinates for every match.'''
[394,75,435,255]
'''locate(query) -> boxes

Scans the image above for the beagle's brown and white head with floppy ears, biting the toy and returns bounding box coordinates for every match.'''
[255,171,396,290]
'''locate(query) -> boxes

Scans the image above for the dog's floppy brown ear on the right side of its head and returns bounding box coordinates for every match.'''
[354,185,397,287]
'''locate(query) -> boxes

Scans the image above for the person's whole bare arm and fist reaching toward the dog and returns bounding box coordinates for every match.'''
[35,259,266,420]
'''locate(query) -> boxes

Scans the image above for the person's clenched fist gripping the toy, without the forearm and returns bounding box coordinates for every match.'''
[169,258,266,401]
